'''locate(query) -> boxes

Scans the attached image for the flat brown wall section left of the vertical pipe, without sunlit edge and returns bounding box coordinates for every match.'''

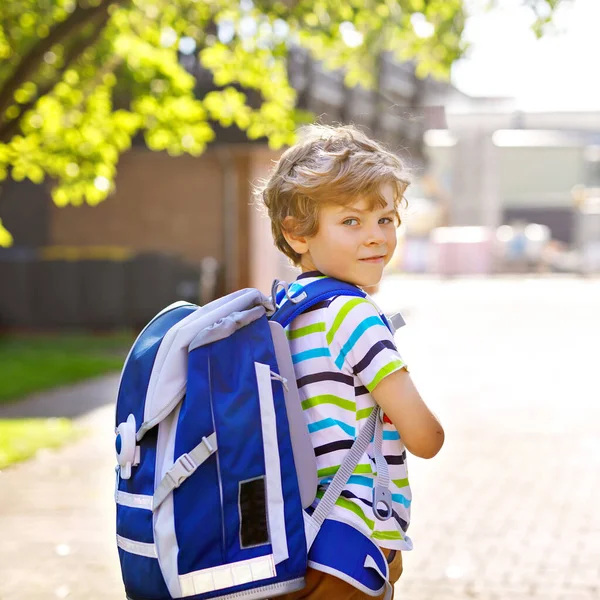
[50,149,223,262]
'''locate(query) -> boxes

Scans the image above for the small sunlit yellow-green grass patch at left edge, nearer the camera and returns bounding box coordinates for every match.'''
[0,419,79,470]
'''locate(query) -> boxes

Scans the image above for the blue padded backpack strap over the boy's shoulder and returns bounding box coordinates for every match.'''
[270,277,367,327]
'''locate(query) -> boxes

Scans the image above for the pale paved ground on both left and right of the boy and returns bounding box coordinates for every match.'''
[0,278,600,600]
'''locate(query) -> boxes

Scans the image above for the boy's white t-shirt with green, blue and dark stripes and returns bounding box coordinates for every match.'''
[287,272,412,550]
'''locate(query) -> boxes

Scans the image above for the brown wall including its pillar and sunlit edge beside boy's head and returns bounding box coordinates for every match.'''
[49,144,295,293]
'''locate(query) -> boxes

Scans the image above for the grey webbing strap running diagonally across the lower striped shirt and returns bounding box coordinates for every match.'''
[306,406,389,549]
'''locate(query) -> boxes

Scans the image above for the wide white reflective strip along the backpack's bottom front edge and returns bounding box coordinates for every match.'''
[179,554,277,598]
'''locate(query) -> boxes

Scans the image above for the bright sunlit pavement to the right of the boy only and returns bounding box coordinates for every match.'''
[381,278,600,600]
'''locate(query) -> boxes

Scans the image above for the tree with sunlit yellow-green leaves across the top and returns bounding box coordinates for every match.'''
[0,0,558,245]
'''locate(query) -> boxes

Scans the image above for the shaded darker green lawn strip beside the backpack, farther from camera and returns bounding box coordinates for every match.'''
[0,333,134,404]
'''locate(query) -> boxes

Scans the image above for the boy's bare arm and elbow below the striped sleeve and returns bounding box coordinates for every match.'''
[371,369,444,458]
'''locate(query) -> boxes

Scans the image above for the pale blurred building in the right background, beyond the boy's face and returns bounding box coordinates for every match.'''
[425,99,600,245]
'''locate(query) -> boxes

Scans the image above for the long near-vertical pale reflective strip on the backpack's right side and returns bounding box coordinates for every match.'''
[254,363,289,565]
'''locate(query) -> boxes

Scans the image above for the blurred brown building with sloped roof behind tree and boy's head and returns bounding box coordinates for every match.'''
[0,51,463,298]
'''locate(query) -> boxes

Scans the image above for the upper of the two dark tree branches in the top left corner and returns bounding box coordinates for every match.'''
[0,0,126,119]
